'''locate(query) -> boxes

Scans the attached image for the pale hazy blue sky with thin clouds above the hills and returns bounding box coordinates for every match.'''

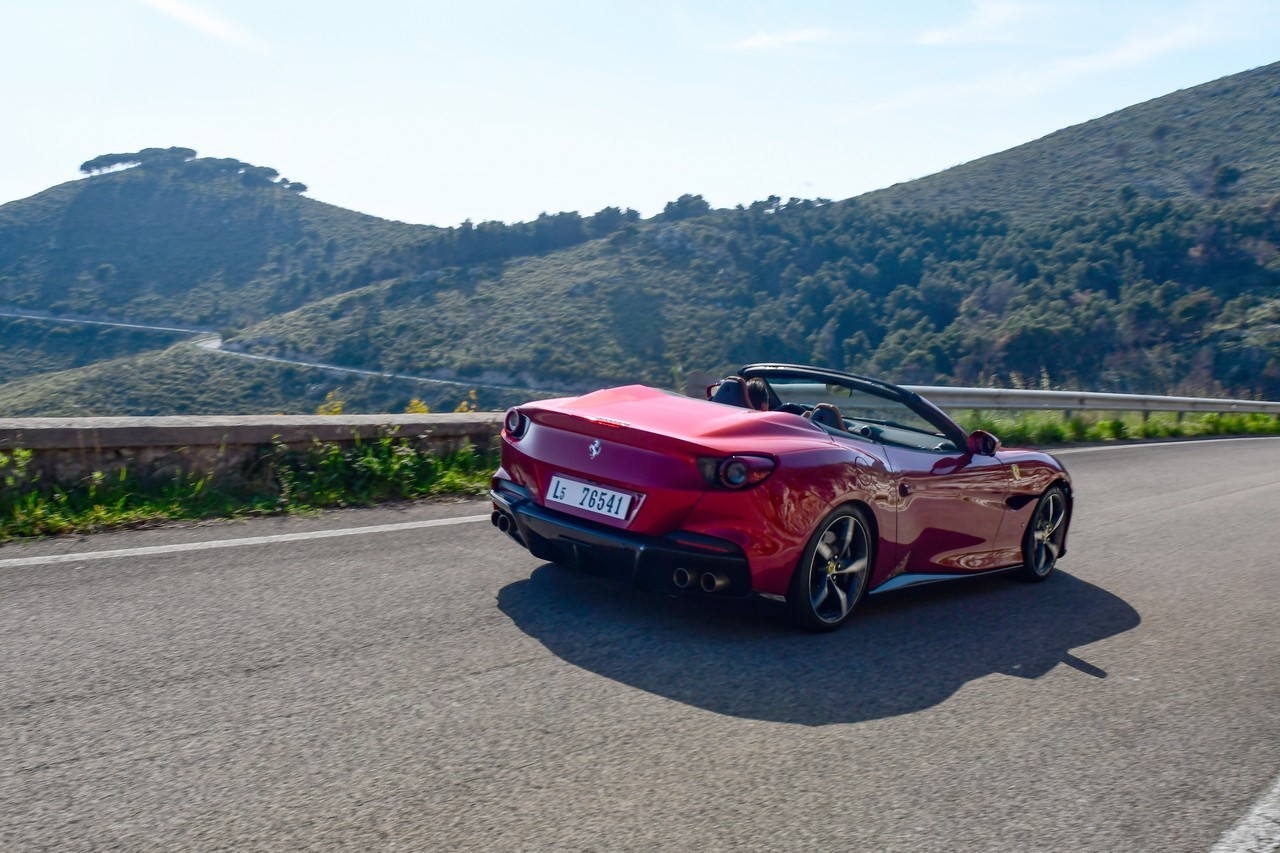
[0,0,1280,225]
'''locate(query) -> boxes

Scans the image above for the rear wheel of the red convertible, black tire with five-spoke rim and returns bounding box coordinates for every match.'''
[787,506,876,631]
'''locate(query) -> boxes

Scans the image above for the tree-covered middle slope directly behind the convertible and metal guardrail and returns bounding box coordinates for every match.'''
[232,200,1280,396]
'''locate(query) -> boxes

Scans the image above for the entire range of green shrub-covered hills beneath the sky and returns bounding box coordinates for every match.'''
[0,64,1280,415]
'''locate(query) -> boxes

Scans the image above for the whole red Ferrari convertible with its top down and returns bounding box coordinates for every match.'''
[490,364,1071,630]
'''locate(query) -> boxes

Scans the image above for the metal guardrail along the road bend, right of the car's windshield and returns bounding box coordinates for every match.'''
[902,386,1280,415]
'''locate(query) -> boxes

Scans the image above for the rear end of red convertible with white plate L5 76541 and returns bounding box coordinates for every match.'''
[490,386,803,596]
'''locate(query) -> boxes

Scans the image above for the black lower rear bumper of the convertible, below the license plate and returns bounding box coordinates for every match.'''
[489,480,751,598]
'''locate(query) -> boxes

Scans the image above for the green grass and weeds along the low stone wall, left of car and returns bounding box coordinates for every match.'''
[0,435,497,542]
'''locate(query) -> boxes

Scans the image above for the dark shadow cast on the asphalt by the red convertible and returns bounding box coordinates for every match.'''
[498,565,1140,726]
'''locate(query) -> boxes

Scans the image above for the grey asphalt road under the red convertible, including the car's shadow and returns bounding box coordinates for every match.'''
[0,439,1280,853]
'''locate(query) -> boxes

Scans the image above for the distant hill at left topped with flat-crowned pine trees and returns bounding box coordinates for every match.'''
[0,149,431,325]
